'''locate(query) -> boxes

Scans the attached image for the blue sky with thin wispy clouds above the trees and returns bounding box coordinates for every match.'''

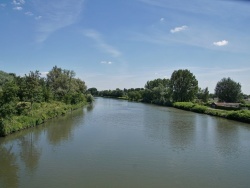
[0,0,250,94]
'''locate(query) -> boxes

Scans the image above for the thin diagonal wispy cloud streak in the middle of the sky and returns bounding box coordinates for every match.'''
[84,30,121,57]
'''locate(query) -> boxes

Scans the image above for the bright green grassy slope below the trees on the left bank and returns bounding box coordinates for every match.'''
[0,101,87,136]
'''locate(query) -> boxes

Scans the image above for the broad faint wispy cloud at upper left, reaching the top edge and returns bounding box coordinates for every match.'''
[34,0,84,43]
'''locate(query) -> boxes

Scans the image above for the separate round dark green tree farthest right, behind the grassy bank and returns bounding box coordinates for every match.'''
[214,77,242,102]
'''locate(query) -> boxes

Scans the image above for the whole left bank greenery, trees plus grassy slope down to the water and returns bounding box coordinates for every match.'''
[0,66,93,135]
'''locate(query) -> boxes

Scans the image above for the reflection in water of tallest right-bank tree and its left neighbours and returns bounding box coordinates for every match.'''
[143,106,195,150]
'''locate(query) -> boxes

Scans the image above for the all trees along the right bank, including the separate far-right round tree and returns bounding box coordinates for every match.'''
[88,69,248,106]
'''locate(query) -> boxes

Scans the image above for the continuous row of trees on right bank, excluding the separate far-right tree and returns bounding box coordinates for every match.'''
[88,70,209,105]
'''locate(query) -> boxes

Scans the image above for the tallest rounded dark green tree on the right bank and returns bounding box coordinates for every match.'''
[170,69,198,102]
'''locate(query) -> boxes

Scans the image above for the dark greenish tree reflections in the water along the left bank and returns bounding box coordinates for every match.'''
[0,107,87,188]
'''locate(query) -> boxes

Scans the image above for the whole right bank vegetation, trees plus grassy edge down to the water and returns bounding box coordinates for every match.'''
[88,69,250,123]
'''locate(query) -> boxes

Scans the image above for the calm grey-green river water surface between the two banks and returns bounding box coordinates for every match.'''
[0,98,250,188]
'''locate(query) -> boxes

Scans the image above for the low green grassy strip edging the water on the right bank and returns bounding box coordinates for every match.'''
[173,102,250,123]
